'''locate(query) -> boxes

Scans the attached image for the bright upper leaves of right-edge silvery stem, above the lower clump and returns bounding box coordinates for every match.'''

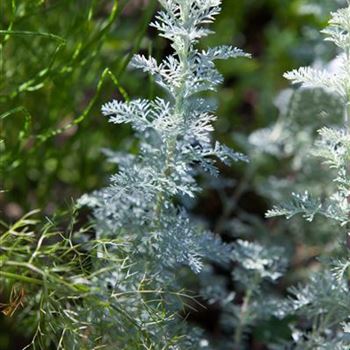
[267,7,350,225]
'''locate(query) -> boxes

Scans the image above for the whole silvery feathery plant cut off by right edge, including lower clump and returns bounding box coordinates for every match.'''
[267,3,350,349]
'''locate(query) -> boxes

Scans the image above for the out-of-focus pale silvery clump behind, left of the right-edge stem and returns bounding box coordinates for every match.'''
[249,88,343,159]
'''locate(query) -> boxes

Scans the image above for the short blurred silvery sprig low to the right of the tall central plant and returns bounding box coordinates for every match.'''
[200,239,287,350]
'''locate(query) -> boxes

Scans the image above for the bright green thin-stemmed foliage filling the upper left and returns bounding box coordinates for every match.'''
[0,0,154,213]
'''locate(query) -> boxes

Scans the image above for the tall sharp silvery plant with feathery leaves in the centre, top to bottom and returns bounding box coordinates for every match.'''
[80,0,249,349]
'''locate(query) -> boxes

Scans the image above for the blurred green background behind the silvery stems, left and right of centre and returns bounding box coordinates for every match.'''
[0,0,338,350]
